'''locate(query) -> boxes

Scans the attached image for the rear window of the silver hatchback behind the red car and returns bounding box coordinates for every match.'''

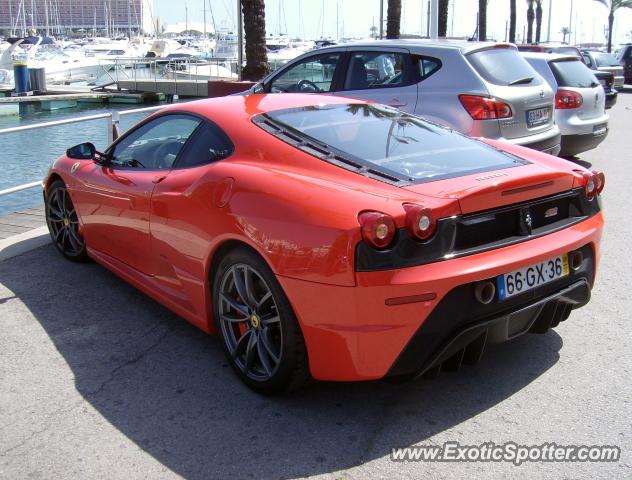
[467,48,542,85]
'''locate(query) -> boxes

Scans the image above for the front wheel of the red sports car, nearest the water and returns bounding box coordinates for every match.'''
[44,180,88,262]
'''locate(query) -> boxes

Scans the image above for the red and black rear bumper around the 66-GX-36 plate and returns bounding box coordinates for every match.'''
[278,213,603,381]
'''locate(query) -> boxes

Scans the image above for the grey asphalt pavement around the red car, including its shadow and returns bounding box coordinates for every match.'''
[0,94,632,479]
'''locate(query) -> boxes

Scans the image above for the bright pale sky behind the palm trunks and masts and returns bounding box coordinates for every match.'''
[154,0,632,42]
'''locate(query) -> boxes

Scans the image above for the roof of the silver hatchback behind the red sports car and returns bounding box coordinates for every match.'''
[309,38,516,54]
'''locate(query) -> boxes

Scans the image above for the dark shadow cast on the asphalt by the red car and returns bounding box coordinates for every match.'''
[0,246,562,479]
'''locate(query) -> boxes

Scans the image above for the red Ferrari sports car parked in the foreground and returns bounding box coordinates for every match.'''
[45,94,605,393]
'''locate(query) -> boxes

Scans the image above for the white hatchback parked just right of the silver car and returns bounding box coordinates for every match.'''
[522,52,609,156]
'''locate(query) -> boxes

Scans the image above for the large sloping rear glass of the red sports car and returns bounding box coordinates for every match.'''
[255,104,525,182]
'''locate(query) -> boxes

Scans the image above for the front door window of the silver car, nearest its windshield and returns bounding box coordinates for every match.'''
[270,53,340,93]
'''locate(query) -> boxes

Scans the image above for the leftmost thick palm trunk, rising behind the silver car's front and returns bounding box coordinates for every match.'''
[241,0,268,82]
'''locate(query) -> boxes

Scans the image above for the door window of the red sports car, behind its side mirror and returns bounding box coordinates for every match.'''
[109,115,200,170]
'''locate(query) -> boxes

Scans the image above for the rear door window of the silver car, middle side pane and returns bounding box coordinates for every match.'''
[344,52,407,90]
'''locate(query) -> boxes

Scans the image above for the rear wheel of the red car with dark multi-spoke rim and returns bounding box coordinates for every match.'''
[213,249,310,395]
